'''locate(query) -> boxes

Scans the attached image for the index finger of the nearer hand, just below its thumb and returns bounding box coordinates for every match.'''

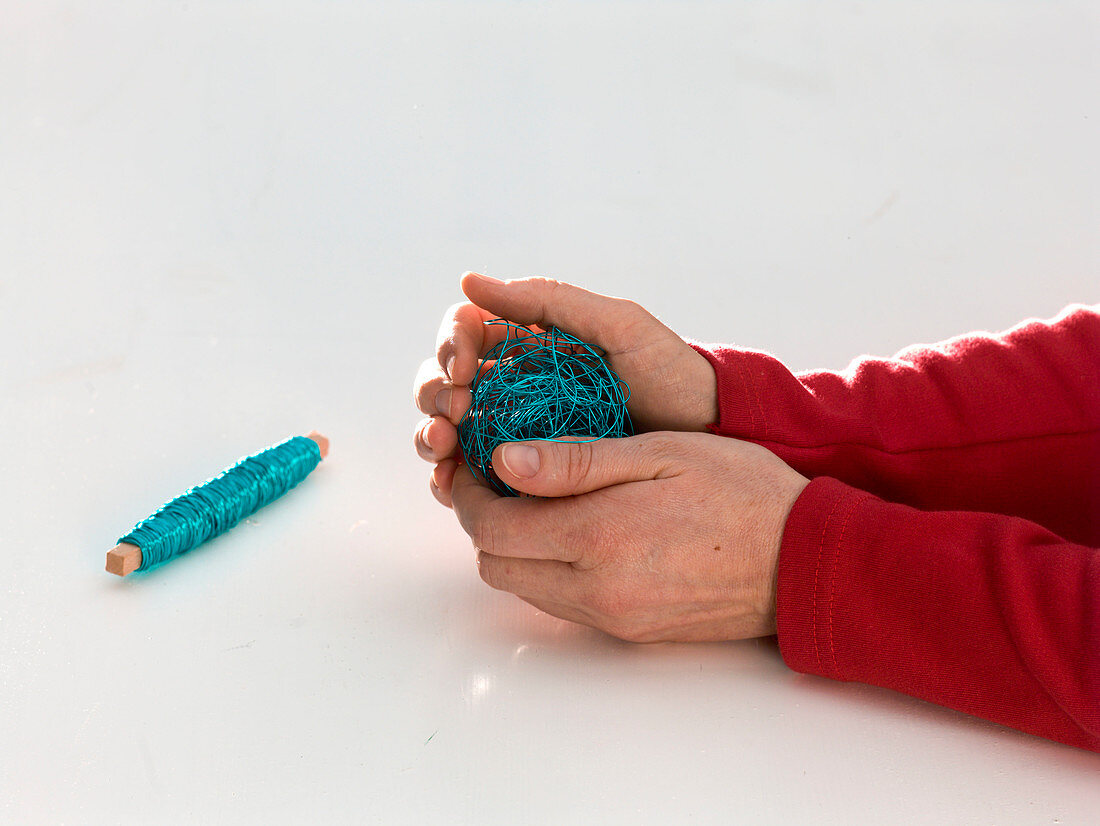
[451,466,598,563]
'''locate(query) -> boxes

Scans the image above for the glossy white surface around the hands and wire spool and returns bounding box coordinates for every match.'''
[0,1,1100,824]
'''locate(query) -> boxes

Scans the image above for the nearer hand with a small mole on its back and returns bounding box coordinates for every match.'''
[453,432,809,642]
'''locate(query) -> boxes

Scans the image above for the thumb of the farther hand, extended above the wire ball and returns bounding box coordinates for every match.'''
[462,273,646,351]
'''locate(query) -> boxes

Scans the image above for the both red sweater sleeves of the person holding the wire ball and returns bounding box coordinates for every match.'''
[696,307,1100,751]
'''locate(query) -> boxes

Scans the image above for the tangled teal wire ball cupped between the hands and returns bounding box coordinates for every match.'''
[459,319,634,496]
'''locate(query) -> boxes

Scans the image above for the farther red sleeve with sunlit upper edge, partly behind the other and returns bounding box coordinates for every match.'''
[696,307,1100,544]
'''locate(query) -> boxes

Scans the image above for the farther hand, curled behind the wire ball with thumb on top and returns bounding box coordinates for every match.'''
[414,273,718,507]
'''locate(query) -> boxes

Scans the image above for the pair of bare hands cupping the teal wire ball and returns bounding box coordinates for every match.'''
[414,273,809,642]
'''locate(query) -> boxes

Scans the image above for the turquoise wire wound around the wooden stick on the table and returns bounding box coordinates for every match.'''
[119,436,321,571]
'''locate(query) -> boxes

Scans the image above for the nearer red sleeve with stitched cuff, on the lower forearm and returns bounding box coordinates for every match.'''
[777,477,1100,751]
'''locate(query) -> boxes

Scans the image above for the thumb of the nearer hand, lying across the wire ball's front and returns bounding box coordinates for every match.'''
[493,433,675,496]
